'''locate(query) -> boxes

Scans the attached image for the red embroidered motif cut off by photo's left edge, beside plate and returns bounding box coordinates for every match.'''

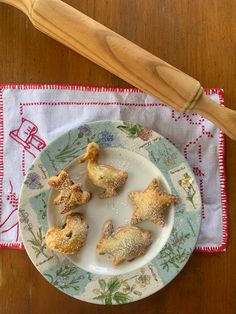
[0,181,19,242]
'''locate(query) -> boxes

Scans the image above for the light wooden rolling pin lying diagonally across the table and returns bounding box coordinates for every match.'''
[0,0,236,140]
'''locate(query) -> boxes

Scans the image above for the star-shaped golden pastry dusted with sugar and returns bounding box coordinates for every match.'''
[129,179,178,227]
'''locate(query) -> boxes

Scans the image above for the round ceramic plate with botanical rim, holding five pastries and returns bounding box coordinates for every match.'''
[19,121,201,304]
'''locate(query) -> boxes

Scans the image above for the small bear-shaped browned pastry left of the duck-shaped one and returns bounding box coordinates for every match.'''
[48,170,91,214]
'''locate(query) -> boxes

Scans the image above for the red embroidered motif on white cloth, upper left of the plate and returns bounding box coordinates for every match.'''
[9,118,46,157]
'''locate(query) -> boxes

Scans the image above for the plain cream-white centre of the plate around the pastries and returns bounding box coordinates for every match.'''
[48,148,174,276]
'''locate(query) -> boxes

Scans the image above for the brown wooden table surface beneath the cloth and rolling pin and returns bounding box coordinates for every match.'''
[0,0,236,314]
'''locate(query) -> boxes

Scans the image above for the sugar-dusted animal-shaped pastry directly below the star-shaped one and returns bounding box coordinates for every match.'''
[97,220,152,266]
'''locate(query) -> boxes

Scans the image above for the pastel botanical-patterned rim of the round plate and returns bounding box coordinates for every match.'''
[19,121,201,304]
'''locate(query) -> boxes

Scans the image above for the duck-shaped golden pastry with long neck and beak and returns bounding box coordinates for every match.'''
[79,142,128,198]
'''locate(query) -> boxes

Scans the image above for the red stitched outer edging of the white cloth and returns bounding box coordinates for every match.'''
[0,84,228,253]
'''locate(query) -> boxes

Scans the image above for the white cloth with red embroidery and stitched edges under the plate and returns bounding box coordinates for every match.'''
[0,85,228,252]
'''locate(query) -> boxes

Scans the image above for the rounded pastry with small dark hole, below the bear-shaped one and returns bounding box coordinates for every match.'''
[45,213,88,254]
